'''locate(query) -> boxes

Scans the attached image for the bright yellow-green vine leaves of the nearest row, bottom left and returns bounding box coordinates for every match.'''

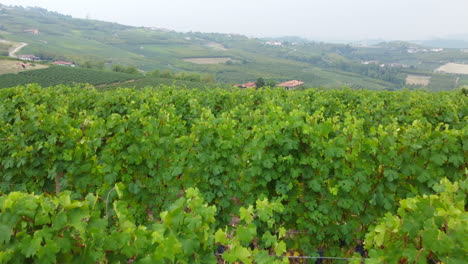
[0,187,288,263]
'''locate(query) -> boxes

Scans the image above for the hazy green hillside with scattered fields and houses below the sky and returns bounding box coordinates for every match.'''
[0,6,468,90]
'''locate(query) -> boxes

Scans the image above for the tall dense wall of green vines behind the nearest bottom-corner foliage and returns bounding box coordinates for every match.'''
[0,85,468,255]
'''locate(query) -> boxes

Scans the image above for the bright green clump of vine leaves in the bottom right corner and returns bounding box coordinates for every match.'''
[366,179,468,264]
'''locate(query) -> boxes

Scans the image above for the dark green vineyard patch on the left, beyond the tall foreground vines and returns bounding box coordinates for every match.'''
[0,66,142,88]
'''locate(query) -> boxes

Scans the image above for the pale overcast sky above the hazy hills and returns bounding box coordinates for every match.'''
[0,0,468,41]
